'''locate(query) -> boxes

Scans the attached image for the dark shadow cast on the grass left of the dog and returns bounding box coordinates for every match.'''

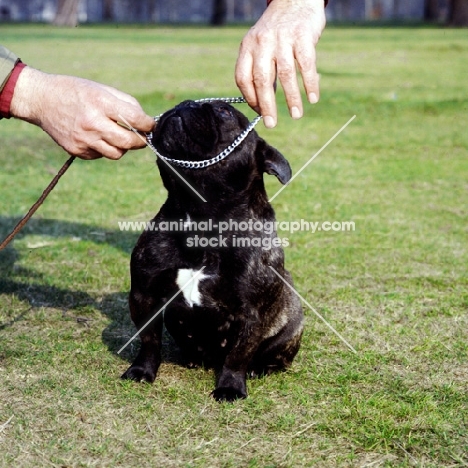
[0,216,181,364]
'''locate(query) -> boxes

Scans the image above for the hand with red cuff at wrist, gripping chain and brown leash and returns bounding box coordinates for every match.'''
[10,67,154,159]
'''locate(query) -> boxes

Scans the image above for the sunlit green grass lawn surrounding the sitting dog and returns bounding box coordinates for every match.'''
[0,26,468,468]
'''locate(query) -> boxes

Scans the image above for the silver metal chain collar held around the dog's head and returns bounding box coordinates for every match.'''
[146,97,262,169]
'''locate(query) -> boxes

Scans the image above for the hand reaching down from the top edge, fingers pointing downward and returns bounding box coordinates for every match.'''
[235,0,326,128]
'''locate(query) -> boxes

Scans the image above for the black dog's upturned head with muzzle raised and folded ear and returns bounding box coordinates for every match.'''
[152,101,291,197]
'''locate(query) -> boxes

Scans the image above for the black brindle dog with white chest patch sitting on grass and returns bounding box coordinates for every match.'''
[122,101,303,401]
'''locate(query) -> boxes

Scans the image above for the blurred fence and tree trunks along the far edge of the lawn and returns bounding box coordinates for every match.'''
[0,0,468,26]
